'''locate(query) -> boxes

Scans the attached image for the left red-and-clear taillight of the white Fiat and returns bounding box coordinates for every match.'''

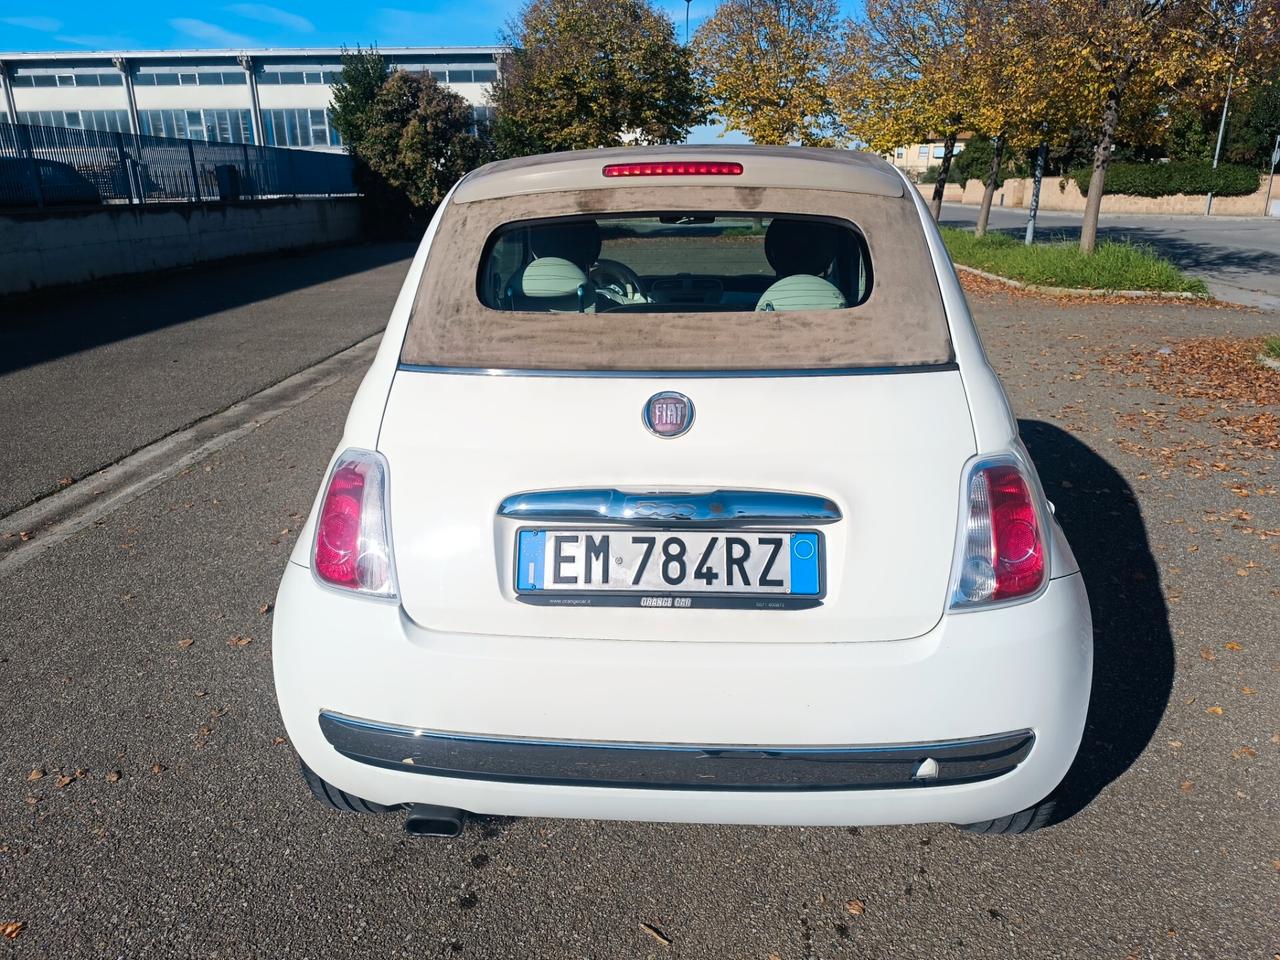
[311,449,396,598]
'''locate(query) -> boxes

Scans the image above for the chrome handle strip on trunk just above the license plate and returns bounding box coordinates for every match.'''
[498,488,841,526]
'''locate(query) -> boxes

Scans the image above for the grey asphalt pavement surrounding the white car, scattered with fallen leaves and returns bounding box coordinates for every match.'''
[0,248,1280,960]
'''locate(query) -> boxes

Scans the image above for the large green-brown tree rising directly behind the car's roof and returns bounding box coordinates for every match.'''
[490,0,705,156]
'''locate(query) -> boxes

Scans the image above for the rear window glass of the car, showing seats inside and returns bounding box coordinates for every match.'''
[476,210,872,314]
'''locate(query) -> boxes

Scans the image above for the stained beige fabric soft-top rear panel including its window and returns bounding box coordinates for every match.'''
[401,184,952,372]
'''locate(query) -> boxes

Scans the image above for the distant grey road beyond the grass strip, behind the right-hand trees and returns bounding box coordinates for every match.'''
[942,204,1280,310]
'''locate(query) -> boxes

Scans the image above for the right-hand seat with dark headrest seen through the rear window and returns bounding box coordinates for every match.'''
[755,218,849,310]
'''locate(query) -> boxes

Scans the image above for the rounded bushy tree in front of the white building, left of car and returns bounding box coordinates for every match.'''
[366,70,489,210]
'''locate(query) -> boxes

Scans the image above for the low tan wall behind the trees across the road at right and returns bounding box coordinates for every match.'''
[942,177,1280,216]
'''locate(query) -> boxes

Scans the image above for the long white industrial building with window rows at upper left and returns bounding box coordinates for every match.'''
[0,46,502,150]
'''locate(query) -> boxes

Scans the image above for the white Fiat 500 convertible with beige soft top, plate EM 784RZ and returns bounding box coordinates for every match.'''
[274,147,1092,835]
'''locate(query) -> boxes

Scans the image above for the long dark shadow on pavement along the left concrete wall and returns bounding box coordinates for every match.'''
[0,243,413,374]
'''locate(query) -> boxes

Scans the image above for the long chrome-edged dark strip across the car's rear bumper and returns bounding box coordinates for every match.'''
[320,710,1036,791]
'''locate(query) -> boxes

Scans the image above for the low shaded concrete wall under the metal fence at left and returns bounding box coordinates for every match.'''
[0,197,360,294]
